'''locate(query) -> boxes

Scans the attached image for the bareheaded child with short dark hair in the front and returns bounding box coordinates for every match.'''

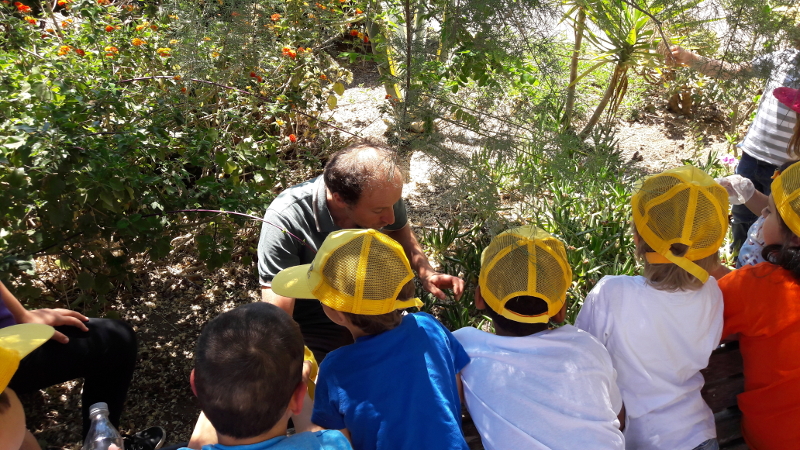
[190,303,351,450]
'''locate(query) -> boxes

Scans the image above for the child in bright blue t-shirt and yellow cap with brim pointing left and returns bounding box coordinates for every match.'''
[272,230,469,450]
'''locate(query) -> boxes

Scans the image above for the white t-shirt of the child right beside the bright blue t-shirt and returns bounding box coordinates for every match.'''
[453,325,625,450]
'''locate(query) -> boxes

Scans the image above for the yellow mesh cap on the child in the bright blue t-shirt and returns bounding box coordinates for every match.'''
[272,229,422,315]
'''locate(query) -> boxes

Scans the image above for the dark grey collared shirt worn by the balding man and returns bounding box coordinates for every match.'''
[258,176,408,326]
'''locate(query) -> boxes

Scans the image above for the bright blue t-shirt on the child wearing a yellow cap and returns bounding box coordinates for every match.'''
[311,313,469,450]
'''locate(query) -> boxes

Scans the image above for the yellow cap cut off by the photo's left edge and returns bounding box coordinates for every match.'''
[0,323,56,392]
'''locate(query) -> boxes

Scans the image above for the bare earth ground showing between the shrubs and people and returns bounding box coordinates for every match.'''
[17,60,727,449]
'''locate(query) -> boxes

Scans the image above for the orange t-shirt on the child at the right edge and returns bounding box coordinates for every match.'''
[719,263,800,450]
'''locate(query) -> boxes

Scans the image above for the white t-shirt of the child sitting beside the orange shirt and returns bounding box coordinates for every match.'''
[575,276,723,450]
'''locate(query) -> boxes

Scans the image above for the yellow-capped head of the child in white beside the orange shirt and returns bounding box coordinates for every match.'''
[631,166,728,291]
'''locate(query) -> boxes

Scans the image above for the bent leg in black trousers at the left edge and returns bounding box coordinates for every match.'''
[9,319,137,438]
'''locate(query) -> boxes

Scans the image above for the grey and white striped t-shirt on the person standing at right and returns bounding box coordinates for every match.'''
[739,49,800,166]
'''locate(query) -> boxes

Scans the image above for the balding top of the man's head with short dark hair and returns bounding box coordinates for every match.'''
[323,141,403,206]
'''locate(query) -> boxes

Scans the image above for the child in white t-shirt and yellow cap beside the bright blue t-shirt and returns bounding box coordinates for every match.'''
[453,227,625,450]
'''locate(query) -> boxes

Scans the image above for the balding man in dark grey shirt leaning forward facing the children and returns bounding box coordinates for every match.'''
[258,143,464,362]
